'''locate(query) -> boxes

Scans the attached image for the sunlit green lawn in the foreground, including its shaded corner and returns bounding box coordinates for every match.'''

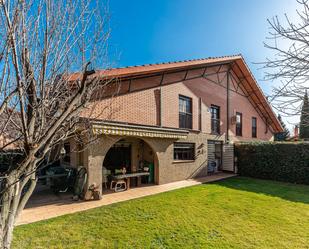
[13,177,309,249]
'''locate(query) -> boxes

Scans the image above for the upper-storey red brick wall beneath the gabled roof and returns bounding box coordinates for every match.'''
[83,67,272,140]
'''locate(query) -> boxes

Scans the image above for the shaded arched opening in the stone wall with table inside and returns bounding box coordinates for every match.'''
[102,137,158,189]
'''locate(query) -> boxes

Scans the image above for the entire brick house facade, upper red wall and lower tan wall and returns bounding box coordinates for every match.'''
[73,58,280,195]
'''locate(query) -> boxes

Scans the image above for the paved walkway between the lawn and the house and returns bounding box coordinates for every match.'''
[17,173,235,225]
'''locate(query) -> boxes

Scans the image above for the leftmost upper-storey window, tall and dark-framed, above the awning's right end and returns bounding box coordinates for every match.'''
[179,95,192,129]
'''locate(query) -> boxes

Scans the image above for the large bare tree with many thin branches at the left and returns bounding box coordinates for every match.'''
[0,0,109,248]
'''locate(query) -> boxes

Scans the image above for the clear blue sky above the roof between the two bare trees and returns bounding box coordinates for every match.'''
[109,0,297,128]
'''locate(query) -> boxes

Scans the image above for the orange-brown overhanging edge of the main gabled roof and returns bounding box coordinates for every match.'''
[74,55,283,133]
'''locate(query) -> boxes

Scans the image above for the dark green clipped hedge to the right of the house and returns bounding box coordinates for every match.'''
[235,143,309,185]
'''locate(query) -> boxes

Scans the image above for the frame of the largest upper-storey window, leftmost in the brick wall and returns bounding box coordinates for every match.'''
[178,95,193,130]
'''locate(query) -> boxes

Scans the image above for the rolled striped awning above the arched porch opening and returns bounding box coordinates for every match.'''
[92,122,189,139]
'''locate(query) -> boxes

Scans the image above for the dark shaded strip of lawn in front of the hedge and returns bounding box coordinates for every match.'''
[211,176,309,204]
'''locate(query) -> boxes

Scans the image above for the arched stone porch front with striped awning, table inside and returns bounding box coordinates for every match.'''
[84,122,188,194]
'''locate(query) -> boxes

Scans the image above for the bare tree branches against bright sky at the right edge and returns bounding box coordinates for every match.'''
[264,0,309,123]
